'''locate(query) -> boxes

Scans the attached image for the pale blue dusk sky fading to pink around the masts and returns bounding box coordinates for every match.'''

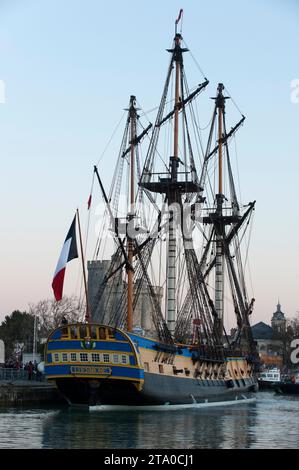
[0,0,299,323]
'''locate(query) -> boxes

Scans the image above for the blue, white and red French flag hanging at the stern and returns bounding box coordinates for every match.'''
[52,216,78,301]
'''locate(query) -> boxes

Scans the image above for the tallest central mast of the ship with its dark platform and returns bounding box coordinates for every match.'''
[139,15,205,338]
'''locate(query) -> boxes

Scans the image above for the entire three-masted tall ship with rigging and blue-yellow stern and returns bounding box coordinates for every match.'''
[45,12,258,407]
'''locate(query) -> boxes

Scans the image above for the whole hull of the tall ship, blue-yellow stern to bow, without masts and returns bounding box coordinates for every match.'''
[45,324,257,406]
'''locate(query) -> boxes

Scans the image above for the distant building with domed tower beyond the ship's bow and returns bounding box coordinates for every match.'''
[251,302,286,368]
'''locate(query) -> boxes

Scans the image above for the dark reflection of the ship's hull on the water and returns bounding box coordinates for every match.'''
[43,404,256,449]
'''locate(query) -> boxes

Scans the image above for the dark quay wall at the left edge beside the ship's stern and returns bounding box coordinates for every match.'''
[0,369,66,406]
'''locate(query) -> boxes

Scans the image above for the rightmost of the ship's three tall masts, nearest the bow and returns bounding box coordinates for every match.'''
[203,83,256,354]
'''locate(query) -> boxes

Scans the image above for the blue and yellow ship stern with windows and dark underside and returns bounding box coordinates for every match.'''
[45,324,144,405]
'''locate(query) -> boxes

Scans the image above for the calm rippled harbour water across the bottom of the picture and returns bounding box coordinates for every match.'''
[0,392,299,449]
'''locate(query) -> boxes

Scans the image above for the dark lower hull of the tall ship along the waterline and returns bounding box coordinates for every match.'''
[52,373,256,406]
